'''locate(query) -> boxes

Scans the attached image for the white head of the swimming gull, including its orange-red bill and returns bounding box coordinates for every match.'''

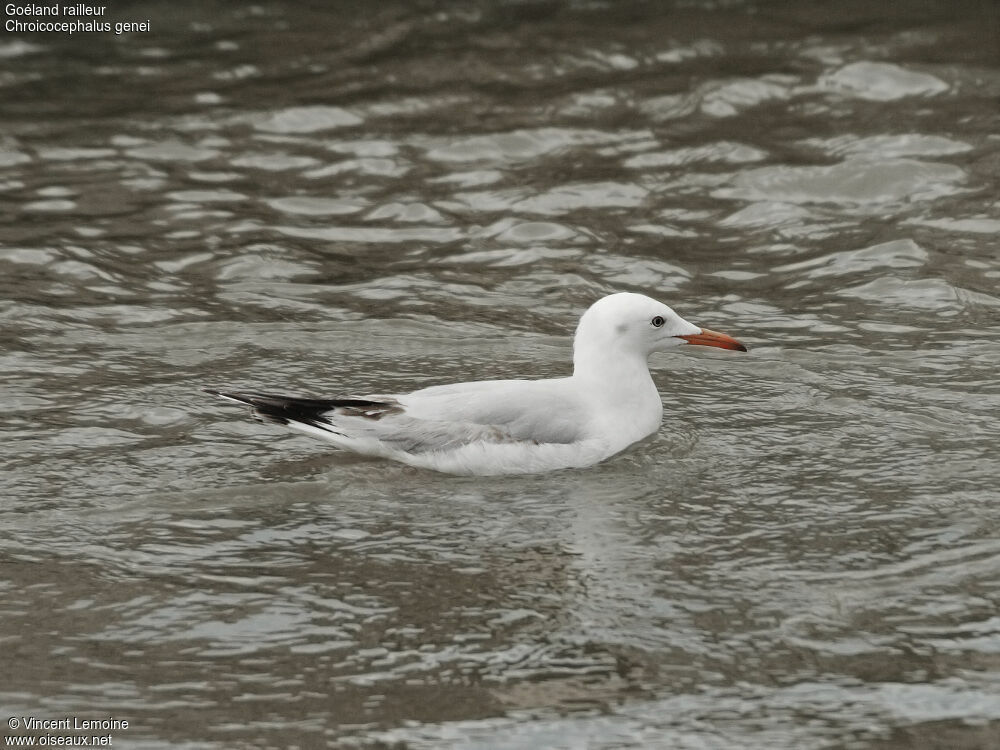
[573,292,747,360]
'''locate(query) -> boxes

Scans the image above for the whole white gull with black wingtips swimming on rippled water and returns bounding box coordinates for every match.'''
[204,292,747,476]
